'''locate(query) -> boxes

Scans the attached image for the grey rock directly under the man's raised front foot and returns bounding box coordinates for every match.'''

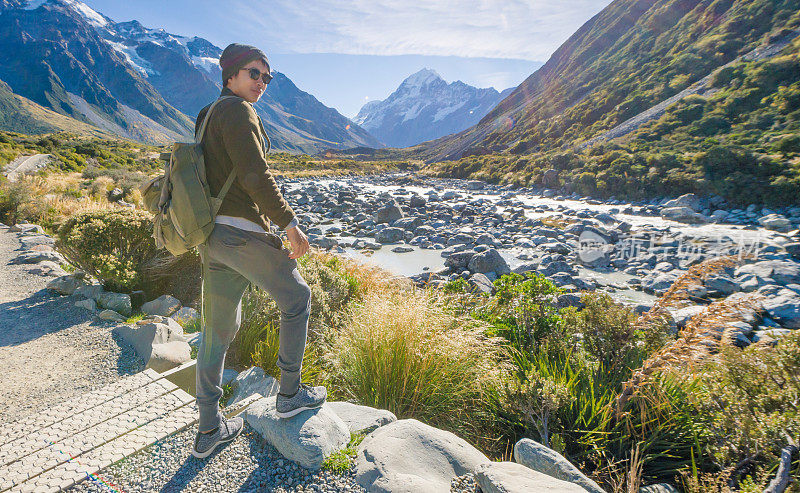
[244,396,346,470]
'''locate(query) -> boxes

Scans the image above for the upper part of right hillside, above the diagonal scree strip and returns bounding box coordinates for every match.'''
[419,0,800,160]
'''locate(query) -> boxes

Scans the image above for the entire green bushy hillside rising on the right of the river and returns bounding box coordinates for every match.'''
[418,0,800,204]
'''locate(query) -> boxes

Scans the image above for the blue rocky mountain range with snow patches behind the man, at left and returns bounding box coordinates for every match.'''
[0,0,381,153]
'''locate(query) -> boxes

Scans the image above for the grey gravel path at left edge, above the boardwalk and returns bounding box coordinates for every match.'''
[0,228,143,423]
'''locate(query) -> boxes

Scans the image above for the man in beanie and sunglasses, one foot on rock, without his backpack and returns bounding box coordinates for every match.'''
[192,44,327,458]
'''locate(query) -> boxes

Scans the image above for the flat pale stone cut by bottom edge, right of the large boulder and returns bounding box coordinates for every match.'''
[475,462,586,493]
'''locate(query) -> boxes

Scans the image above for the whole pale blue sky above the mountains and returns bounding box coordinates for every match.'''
[84,0,611,117]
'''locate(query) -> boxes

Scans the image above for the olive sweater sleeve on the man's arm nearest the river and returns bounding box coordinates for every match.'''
[221,101,295,229]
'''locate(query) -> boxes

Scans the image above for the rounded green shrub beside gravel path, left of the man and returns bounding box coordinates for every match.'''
[58,209,163,292]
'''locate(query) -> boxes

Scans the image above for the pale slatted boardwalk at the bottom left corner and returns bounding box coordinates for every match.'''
[0,365,253,493]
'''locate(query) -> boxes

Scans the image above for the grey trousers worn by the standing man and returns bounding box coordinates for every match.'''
[197,224,311,432]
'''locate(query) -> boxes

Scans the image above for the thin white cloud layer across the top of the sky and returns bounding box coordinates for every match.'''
[226,0,610,61]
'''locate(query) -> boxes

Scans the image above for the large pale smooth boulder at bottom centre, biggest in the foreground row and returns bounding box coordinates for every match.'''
[355,419,489,493]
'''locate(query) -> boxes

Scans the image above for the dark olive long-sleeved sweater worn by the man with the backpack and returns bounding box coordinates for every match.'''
[195,87,295,230]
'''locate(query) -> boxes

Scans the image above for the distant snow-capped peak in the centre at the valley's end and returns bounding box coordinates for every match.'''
[354,69,512,147]
